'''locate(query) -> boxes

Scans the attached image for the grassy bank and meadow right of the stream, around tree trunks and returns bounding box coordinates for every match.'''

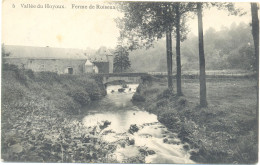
[133,77,258,163]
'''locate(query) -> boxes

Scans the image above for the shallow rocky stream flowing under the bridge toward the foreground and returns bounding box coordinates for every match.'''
[82,84,194,163]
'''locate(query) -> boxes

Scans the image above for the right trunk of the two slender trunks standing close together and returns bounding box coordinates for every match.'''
[175,3,183,96]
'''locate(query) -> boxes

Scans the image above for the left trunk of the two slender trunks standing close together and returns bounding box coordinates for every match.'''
[166,28,173,91]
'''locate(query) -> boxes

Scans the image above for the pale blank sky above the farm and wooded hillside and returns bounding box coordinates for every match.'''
[2,0,251,49]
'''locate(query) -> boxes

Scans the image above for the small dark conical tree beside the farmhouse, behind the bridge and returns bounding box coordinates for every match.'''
[114,45,131,72]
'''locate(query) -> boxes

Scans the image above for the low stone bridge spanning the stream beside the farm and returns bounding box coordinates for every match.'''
[99,73,148,84]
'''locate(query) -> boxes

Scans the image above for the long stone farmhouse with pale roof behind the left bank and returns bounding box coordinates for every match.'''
[4,45,113,74]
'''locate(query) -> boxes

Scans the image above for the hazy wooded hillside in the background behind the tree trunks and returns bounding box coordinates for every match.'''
[129,23,256,72]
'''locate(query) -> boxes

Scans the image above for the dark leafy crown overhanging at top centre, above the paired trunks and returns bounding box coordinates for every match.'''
[117,2,194,50]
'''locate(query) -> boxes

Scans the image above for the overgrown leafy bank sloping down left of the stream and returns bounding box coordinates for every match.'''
[1,64,114,162]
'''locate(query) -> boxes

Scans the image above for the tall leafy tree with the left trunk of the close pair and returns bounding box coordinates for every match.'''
[118,2,174,90]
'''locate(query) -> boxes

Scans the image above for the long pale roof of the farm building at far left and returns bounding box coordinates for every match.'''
[4,45,87,60]
